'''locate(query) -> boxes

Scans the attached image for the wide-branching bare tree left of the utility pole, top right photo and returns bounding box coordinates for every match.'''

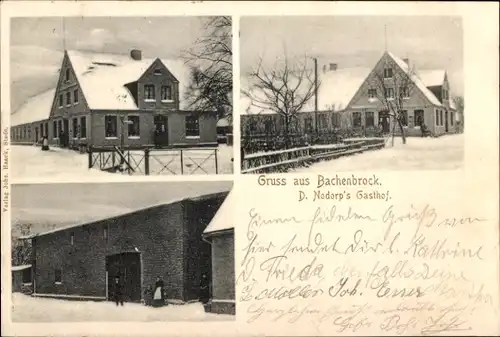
[242,57,319,148]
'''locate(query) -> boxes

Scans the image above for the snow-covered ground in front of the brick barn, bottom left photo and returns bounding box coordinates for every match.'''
[12,293,234,323]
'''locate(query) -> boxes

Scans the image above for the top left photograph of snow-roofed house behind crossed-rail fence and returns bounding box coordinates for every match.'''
[10,16,233,179]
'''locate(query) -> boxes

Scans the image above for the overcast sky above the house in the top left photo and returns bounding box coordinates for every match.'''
[10,16,209,111]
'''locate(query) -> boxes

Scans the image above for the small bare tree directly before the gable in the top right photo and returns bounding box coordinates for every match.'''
[374,60,419,146]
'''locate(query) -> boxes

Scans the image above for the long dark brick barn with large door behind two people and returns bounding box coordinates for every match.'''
[19,192,228,303]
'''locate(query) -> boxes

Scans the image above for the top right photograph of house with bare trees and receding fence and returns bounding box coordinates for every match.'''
[239,15,464,173]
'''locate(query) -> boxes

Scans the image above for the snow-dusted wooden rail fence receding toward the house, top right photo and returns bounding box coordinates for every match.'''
[241,138,385,174]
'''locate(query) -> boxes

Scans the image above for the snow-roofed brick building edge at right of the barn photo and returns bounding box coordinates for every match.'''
[203,190,236,314]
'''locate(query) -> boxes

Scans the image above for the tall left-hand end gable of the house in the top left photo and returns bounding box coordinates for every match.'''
[50,52,89,118]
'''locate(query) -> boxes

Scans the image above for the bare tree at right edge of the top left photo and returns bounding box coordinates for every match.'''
[184,16,233,118]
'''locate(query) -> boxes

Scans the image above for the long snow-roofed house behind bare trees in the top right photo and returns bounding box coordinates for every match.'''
[240,52,460,138]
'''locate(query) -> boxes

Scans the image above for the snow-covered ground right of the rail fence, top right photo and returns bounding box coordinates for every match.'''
[293,134,464,173]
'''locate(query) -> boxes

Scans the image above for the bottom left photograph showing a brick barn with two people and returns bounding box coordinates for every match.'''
[11,181,235,323]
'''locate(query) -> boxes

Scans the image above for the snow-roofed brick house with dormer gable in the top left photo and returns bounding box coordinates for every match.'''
[10,50,217,148]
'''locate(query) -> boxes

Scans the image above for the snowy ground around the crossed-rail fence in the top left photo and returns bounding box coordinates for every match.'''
[10,145,233,180]
